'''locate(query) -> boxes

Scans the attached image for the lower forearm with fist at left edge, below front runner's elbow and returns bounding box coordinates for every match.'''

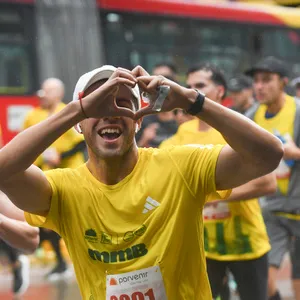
[0,214,39,253]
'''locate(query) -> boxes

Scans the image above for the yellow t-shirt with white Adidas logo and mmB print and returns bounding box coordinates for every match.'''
[25,146,228,300]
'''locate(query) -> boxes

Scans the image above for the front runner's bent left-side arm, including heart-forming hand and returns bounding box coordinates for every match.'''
[0,69,136,216]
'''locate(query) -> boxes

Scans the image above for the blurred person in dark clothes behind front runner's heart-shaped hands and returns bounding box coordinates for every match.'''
[136,63,179,148]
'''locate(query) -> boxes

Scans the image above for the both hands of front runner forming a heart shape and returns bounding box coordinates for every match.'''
[78,66,197,121]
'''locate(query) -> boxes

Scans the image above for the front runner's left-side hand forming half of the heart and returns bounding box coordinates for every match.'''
[81,68,137,119]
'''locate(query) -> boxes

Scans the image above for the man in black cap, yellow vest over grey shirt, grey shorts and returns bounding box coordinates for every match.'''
[246,57,300,300]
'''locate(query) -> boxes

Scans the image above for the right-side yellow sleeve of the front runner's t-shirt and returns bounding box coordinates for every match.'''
[171,144,231,202]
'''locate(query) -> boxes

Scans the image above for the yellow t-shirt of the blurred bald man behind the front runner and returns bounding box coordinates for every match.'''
[23,103,84,171]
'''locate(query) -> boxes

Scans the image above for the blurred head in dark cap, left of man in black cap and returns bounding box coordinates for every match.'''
[228,75,255,114]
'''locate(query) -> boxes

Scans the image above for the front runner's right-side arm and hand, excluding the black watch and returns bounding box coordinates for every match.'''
[138,70,283,190]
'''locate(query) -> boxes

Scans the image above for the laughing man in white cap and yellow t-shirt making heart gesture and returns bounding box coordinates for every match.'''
[0,66,283,300]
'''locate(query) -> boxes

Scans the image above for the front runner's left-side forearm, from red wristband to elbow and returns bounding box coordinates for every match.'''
[0,102,83,182]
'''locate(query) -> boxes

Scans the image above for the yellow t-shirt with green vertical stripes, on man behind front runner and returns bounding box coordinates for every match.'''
[161,119,270,261]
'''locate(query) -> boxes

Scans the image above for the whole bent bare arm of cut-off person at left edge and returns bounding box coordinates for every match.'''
[0,191,39,253]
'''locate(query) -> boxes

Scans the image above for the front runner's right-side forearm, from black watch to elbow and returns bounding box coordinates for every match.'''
[198,98,282,171]
